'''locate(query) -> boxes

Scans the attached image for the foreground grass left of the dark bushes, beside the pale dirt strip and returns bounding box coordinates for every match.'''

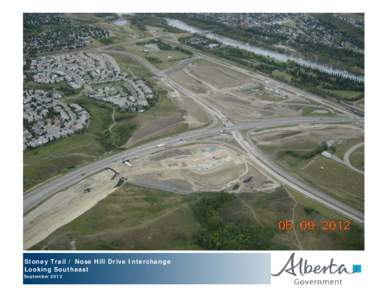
[32,184,198,250]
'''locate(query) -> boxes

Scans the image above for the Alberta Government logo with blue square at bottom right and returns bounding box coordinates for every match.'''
[272,253,362,285]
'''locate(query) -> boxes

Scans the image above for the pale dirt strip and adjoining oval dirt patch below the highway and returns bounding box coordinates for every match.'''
[24,143,279,248]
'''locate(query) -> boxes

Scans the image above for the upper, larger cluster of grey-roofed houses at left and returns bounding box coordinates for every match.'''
[29,52,154,112]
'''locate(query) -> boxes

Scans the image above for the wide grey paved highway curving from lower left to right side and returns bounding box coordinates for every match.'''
[24,117,352,212]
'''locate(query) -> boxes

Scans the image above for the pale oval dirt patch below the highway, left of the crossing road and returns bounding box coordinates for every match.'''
[113,144,274,191]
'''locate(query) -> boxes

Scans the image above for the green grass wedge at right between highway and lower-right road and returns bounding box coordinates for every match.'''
[259,138,364,211]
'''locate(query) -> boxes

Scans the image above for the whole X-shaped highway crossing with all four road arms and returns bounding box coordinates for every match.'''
[24,33,364,223]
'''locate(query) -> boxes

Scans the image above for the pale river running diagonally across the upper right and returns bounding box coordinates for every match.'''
[166,18,364,82]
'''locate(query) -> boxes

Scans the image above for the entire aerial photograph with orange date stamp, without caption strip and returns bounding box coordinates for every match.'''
[23,13,365,251]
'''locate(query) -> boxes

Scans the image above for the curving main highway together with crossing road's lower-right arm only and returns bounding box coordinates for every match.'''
[24,117,363,223]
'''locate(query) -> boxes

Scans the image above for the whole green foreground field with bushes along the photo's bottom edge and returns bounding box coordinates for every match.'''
[33,184,363,250]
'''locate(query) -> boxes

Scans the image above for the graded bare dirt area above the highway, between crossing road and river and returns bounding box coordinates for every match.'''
[168,59,337,122]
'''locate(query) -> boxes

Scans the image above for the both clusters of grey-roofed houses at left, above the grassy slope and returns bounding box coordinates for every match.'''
[23,52,155,149]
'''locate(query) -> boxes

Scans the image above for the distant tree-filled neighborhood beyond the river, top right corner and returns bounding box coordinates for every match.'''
[181,13,364,53]
